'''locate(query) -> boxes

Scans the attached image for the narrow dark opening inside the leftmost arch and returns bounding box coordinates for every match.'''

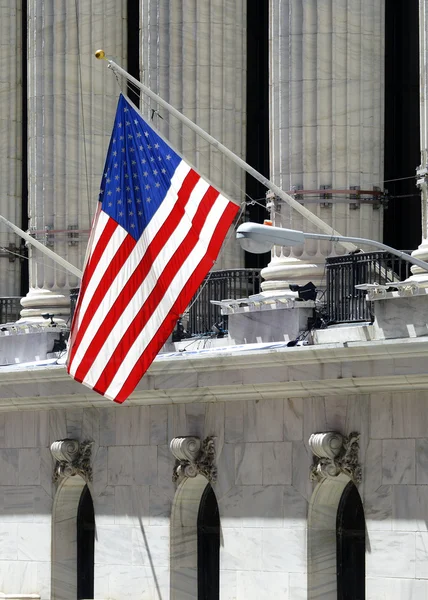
[76,485,95,600]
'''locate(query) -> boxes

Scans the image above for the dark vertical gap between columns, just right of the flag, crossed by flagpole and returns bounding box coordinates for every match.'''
[245,1,270,268]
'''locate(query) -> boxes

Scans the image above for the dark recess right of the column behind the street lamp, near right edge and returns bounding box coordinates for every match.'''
[384,0,421,250]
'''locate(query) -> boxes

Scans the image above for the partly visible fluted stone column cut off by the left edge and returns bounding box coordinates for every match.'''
[0,0,22,296]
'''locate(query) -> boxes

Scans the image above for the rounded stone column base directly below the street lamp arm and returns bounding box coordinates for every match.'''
[261,257,326,298]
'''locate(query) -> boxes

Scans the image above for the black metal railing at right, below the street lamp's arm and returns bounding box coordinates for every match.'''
[326,252,411,324]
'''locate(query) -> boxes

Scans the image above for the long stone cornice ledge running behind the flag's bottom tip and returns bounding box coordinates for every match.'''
[0,338,428,412]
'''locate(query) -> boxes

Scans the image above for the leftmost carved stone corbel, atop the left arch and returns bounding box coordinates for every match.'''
[51,439,93,483]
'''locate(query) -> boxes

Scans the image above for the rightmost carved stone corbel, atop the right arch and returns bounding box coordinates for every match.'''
[309,431,362,483]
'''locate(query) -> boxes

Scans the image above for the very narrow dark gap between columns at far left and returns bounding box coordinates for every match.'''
[17,0,29,296]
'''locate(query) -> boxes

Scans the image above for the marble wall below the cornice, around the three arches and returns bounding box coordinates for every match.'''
[0,391,428,600]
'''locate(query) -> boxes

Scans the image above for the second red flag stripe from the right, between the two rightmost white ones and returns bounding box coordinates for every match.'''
[94,187,226,393]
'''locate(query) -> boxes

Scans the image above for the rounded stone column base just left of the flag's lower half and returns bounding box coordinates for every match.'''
[18,289,70,324]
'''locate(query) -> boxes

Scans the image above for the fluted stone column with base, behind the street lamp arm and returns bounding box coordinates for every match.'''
[262,0,385,293]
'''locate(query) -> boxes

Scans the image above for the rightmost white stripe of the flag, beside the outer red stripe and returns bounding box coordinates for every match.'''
[104,196,229,400]
